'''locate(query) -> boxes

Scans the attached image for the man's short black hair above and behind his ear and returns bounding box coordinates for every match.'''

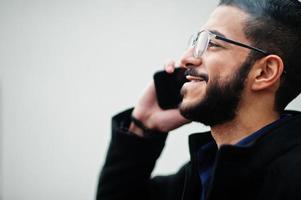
[219,0,301,113]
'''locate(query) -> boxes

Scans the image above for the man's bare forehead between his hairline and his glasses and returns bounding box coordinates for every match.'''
[202,6,248,42]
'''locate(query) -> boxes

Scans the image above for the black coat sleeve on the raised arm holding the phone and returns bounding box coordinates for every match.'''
[96,109,185,200]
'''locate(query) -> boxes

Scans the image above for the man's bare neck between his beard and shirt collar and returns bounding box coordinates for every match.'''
[211,107,280,147]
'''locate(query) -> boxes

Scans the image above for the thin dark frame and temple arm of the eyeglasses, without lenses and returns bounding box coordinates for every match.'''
[190,30,271,58]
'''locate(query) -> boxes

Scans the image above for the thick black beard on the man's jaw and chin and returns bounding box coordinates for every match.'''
[179,58,254,126]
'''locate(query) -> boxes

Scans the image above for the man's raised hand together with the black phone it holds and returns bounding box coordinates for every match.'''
[130,69,190,135]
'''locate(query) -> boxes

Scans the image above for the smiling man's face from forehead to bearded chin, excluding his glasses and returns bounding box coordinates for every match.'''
[180,6,252,126]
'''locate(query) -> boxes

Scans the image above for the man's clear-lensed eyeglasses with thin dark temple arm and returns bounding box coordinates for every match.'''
[189,30,270,58]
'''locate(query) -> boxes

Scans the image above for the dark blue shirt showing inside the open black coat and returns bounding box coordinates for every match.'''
[198,115,290,200]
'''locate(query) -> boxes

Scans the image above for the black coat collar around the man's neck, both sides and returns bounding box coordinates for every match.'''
[189,111,301,166]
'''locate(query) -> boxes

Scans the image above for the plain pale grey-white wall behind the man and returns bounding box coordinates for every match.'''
[0,0,301,200]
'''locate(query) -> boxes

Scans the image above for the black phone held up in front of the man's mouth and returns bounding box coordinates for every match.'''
[154,68,187,110]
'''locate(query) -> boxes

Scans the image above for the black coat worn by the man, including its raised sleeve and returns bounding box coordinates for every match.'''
[97,110,301,200]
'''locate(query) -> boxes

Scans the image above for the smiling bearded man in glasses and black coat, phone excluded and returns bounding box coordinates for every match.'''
[97,0,301,200]
